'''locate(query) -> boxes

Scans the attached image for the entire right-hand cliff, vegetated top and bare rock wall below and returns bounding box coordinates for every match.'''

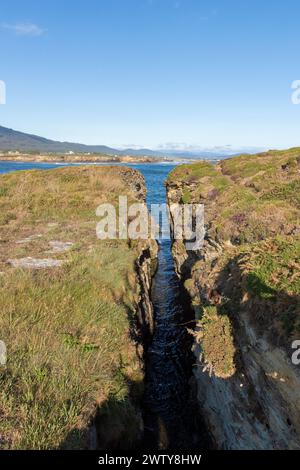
[167,149,300,449]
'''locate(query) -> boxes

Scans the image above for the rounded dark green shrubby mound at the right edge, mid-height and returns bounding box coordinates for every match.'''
[240,235,300,340]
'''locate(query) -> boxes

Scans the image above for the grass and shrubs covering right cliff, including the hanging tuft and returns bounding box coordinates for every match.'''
[168,148,300,377]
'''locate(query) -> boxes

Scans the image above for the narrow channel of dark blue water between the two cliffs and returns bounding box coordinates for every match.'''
[138,165,201,449]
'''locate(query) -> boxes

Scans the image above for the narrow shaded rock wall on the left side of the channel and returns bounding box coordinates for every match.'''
[94,240,158,450]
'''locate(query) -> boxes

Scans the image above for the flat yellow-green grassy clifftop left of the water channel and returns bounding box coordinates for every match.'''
[0,167,150,449]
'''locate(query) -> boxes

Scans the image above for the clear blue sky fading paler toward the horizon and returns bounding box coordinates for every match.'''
[0,0,300,148]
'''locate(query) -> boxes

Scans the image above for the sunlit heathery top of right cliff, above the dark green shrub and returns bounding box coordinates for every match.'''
[168,149,300,245]
